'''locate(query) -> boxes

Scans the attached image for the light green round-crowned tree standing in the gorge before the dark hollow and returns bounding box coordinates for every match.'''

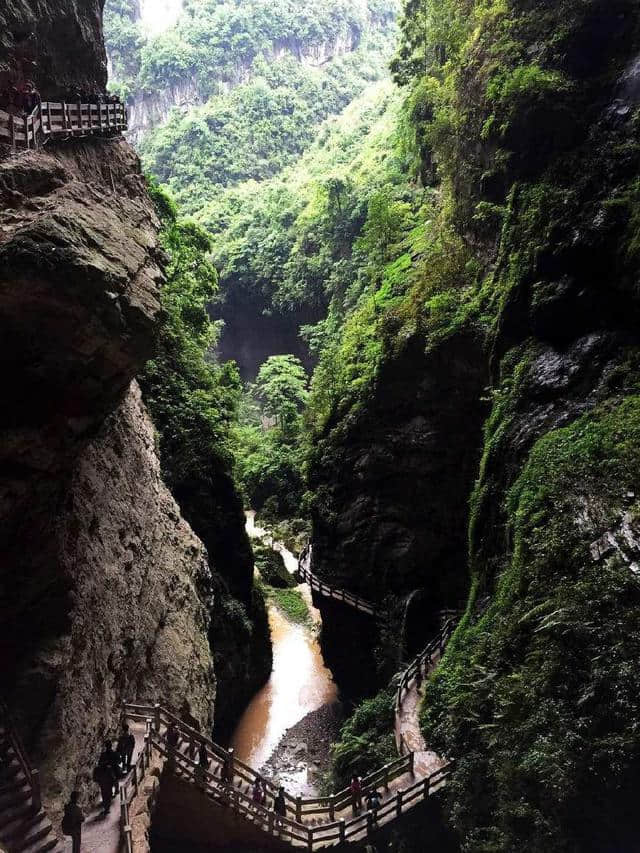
[255,355,309,433]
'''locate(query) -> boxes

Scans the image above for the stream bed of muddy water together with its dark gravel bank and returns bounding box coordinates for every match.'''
[231,512,342,796]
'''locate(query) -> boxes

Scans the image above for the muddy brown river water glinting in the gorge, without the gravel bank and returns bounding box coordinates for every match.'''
[231,512,337,793]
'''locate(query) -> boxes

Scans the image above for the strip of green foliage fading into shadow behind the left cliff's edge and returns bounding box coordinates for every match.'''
[140,178,241,569]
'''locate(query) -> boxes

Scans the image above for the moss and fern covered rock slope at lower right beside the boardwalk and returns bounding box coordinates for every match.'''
[423,395,640,853]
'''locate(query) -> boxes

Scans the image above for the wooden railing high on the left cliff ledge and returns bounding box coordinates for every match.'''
[0,101,127,148]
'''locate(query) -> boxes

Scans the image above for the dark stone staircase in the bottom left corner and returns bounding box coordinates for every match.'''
[0,720,63,853]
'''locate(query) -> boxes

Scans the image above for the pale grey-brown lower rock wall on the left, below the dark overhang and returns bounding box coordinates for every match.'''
[18,382,215,808]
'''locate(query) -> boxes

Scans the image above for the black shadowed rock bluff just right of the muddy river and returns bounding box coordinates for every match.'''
[309,331,488,681]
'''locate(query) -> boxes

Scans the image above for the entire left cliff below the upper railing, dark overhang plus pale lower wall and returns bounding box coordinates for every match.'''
[0,136,215,812]
